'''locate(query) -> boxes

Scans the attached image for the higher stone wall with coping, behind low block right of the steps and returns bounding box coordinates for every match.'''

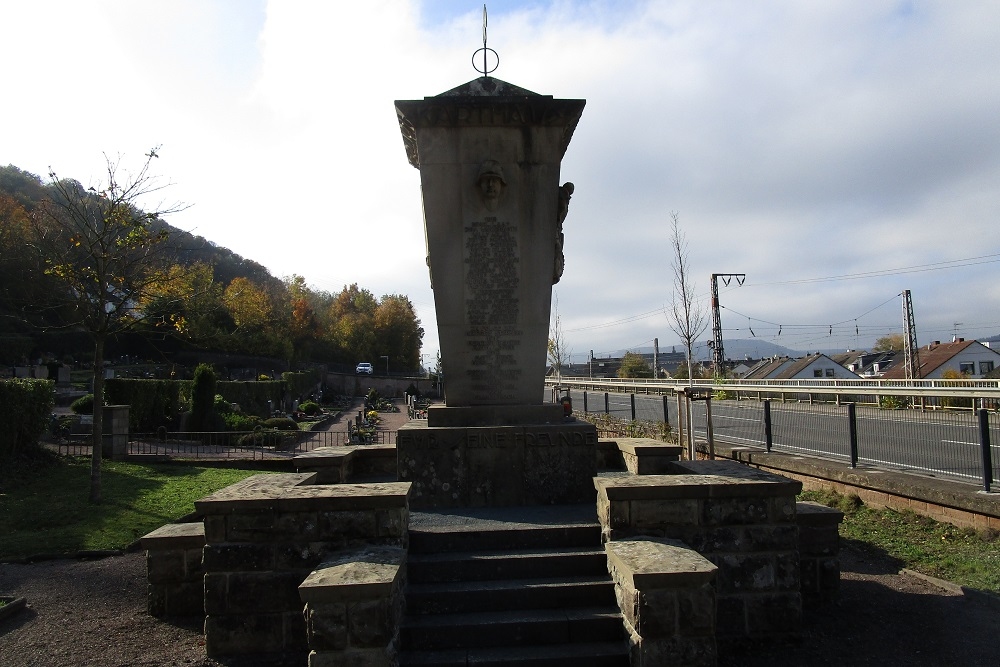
[595,461,802,640]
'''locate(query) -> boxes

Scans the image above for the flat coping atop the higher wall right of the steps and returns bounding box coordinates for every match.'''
[594,466,802,500]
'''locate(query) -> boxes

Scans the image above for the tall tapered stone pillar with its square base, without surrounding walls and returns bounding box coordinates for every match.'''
[396,75,597,507]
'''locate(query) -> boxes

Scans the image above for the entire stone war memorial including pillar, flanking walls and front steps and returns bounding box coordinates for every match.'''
[142,28,842,667]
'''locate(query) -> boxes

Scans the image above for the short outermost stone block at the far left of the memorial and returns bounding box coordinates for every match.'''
[140,522,205,617]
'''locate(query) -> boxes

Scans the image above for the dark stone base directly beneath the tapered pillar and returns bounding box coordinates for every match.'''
[396,406,597,508]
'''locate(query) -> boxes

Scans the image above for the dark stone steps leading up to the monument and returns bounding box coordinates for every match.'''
[400,505,628,667]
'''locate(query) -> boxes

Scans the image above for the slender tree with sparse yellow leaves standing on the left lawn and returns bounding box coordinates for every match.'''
[34,149,183,503]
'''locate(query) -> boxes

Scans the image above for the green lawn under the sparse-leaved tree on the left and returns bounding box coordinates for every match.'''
[0,458,260,560]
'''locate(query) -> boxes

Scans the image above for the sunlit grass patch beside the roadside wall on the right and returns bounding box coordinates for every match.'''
[800,491,1000,592]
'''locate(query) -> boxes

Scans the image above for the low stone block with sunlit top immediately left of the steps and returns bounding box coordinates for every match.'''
[299,547,406,667]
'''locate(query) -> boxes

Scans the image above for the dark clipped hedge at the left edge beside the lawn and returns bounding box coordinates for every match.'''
[0,378,55,460]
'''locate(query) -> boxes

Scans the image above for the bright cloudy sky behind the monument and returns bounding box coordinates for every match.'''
[0,0,1000,364]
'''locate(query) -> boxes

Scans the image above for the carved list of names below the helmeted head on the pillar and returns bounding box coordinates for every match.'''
[463,216,522,404]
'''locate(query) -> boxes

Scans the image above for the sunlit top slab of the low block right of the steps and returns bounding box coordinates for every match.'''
[604,537,719,591]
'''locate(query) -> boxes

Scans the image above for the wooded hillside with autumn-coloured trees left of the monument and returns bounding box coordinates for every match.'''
[0,166,424,370]
